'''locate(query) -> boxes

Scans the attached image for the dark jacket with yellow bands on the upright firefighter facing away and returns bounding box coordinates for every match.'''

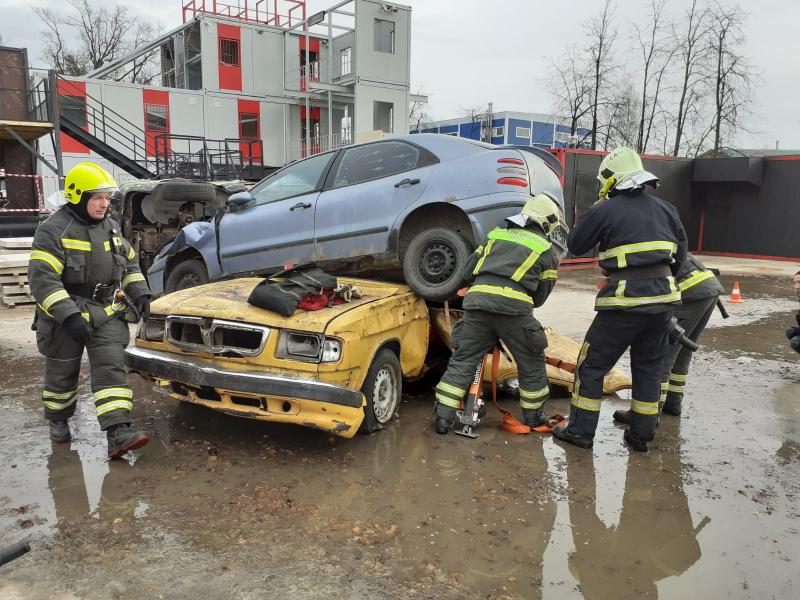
[568,190,688,313]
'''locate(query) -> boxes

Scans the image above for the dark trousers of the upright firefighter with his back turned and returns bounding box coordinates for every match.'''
[568,308,672,442]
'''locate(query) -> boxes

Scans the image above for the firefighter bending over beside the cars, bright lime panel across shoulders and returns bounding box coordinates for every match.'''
[436,194,563,434]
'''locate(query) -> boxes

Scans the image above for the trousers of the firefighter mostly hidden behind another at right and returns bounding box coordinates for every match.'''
[661,296,717,407]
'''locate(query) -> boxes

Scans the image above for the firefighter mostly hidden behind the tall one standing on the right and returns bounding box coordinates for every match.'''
[614,254,725,423]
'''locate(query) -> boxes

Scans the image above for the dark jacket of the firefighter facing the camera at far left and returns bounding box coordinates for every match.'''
[28,207,150,327]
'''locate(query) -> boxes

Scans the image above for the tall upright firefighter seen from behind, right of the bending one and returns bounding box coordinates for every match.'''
[553,147,687,452]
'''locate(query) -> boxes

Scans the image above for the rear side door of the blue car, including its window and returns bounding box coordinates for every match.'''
[314,140,439,261]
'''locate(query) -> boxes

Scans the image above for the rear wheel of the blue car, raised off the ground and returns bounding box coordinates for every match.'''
[403,227,472,302]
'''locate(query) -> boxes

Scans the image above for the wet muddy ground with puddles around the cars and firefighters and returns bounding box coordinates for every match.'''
[0,271,800,600]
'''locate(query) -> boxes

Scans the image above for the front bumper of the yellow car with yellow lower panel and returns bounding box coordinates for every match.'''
[125,346,364,438]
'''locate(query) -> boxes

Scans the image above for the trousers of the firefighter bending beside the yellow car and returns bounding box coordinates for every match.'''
[436,310,550,411]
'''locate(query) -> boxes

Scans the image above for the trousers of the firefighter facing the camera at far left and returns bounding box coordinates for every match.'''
[36,318,133,431]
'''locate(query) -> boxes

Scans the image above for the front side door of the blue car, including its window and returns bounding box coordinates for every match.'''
[218,152,336,275]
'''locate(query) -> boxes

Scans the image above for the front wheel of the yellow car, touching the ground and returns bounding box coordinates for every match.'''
[359,348,403,433]
